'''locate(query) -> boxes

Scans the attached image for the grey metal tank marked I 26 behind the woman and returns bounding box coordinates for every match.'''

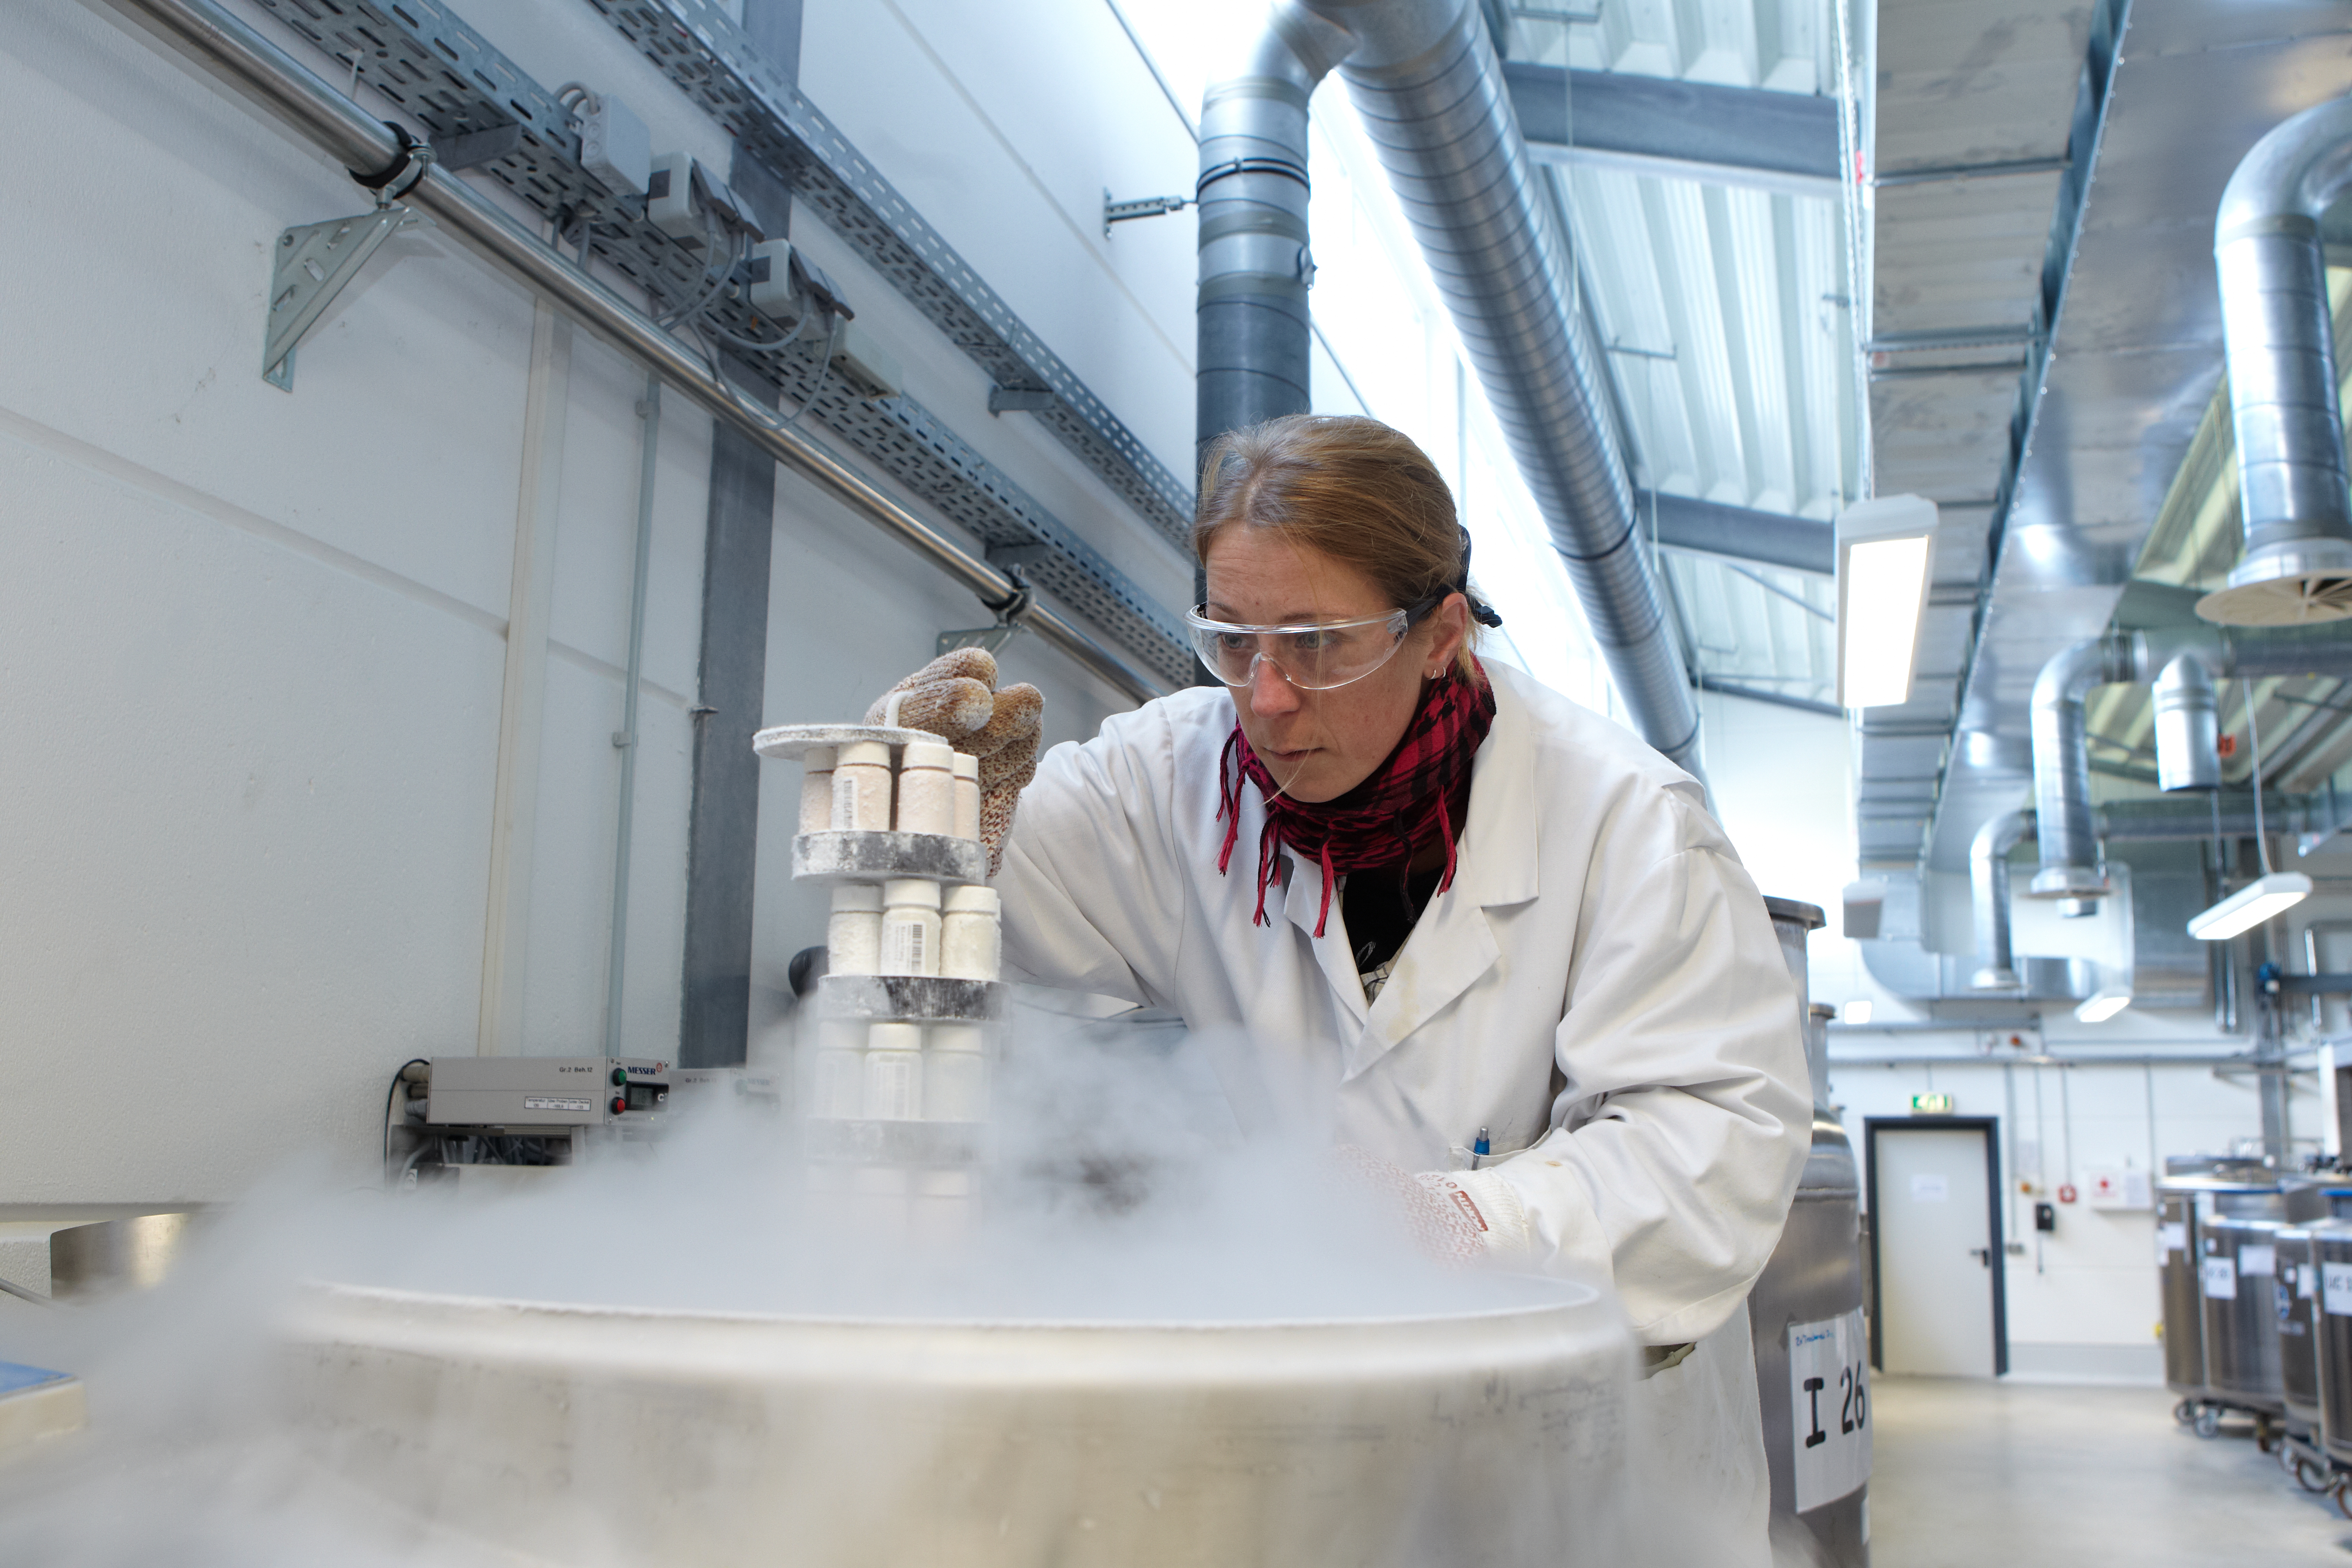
[1748,898,1870,1568]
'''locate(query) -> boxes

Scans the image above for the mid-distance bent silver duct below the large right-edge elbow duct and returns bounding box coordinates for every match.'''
[2027,625,2352,900]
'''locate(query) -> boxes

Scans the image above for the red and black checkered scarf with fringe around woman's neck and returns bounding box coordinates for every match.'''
[1216,658,1494,936]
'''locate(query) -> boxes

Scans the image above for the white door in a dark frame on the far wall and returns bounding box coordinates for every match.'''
[1872,1126,1997,1378]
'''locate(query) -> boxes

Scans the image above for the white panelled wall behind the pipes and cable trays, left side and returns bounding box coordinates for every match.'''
[0,0,1192,1203]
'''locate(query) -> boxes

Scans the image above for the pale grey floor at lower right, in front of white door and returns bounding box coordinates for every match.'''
[1870,1378,2352,1568]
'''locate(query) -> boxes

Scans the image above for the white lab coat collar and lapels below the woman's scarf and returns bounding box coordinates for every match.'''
[1282,670,1538,1079]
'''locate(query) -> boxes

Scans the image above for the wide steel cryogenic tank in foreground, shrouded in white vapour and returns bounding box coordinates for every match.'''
[287,1279,1640,1568]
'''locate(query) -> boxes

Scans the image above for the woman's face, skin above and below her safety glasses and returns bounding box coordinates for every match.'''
[1207,524,1468,802]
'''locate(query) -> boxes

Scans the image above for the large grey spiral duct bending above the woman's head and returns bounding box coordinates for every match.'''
[1200,0,1698,773]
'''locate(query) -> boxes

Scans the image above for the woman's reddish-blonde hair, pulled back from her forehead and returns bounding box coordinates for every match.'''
[1192,414,1480,682]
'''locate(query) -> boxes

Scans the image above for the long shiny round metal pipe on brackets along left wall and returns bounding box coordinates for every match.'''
[108,0,1164,703]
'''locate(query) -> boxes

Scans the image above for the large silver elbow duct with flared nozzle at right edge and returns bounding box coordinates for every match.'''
[2197,99,2352,625]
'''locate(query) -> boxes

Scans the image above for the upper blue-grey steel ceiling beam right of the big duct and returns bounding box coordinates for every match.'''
[1503,61,1842,197]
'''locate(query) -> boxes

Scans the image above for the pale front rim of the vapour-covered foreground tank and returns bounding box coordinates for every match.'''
[301,1272,1599,1335]
